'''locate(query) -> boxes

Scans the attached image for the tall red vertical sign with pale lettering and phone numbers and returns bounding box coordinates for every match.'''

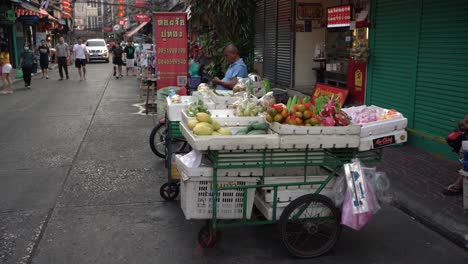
[154,12,188,88]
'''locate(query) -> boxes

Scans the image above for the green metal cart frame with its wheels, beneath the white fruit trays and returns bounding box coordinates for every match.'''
[192,148,381,258]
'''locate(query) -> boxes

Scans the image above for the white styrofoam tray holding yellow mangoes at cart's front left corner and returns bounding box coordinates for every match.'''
[179,122,279,150]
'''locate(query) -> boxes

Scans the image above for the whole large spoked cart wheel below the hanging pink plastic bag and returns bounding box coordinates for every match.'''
[279,194,341,258]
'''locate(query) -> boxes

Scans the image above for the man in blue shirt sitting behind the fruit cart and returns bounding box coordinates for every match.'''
[212,44,247,90]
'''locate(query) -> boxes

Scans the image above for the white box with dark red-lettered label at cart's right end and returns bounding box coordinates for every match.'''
[359,130,408,151]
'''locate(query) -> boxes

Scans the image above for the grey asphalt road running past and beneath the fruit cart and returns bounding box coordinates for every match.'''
[0,64,468,264]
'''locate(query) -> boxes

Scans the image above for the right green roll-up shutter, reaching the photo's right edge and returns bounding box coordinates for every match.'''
[414,0,468,138]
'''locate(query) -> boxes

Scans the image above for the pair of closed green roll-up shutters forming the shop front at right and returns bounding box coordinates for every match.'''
[366,0,468,158]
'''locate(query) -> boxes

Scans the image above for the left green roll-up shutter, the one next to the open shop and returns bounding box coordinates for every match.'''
[366,0,418,117]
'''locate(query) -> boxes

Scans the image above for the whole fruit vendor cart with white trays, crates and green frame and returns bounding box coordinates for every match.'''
[158,92,406,258]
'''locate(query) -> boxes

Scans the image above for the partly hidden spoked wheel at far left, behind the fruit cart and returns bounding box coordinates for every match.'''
[149,123,187,159]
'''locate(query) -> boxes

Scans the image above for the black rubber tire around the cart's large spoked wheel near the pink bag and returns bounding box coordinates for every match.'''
[278,194,341,258]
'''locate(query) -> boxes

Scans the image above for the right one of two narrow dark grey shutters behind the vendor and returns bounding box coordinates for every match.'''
[276,0,293,87]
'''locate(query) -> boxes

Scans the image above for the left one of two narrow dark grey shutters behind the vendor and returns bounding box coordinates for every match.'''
[263,0,277,83]
